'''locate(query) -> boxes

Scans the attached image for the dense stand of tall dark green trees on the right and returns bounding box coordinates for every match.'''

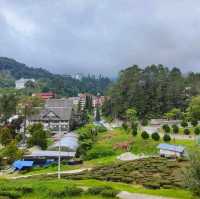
[103,65,200,119]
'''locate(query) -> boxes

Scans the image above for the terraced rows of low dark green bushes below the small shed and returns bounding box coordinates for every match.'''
[65,157,187,189]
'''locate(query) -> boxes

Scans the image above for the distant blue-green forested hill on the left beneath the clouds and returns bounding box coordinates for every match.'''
[0,57,110,96]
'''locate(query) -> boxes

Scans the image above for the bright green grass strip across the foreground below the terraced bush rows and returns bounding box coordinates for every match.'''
[0,179,194,199]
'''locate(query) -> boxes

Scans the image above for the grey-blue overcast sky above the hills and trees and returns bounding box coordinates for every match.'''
[0,0,200,76]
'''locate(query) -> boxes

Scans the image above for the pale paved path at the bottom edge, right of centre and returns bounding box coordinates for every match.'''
[118,191,172,199]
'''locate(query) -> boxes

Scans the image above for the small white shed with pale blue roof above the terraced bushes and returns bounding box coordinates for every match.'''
[157,143,185,157]
